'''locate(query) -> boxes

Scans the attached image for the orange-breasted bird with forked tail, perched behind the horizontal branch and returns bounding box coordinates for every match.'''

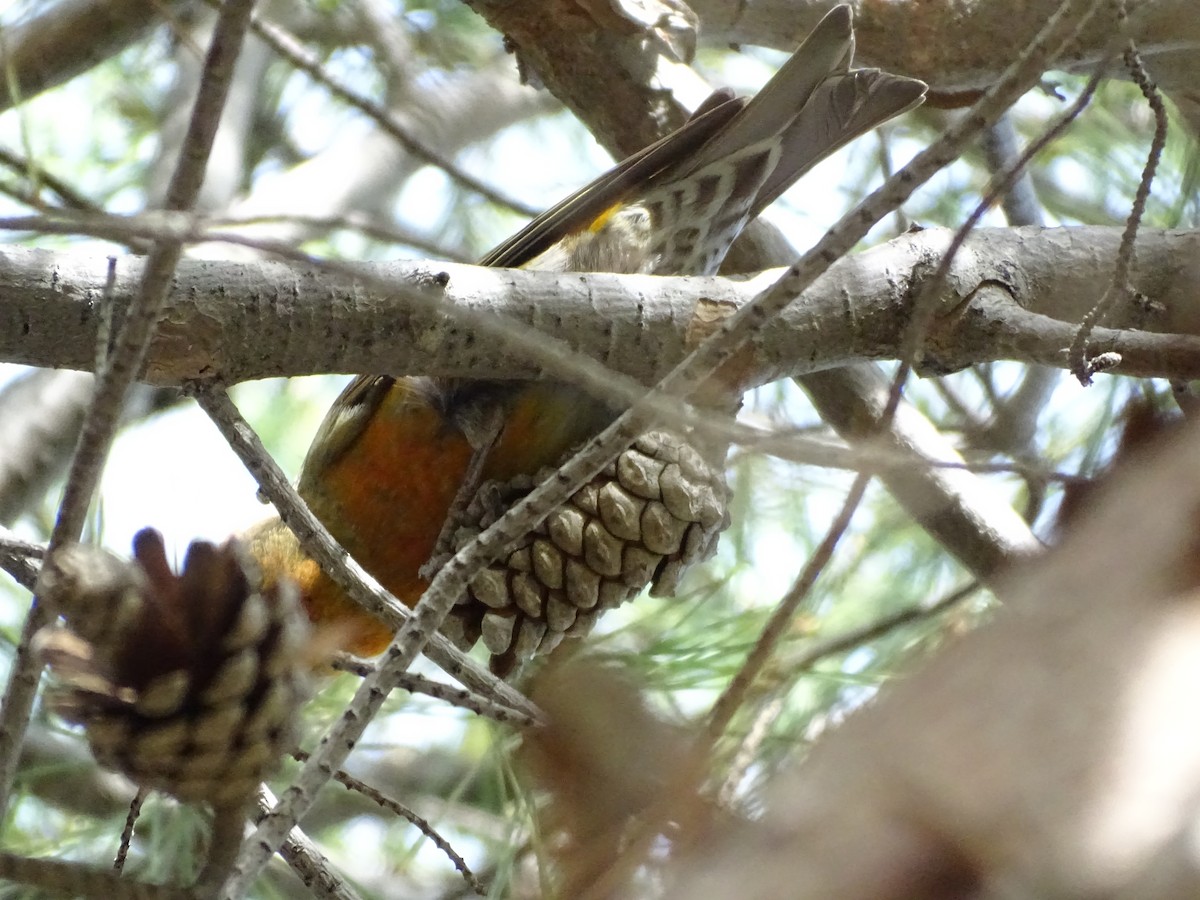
[247,6,925,672]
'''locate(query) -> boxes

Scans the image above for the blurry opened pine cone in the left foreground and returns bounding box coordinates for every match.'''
[36,529,310,806]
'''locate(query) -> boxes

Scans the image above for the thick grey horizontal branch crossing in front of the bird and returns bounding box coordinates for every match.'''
[0,228,1200,384]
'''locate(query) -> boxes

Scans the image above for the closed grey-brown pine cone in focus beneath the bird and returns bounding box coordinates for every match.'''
[442,431,728,676]
